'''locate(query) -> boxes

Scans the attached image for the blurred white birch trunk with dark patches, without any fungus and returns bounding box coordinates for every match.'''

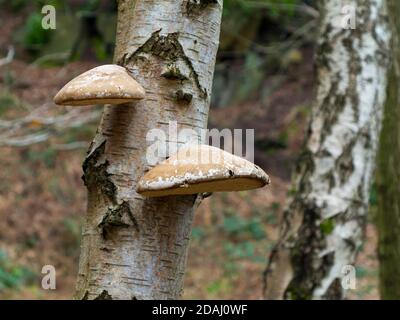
[264,0,390,299]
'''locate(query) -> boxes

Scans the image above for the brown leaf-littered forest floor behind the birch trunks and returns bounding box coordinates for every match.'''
[0,10,379,299]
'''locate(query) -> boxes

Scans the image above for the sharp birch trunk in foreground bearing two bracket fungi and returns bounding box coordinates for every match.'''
[76,0,222,299]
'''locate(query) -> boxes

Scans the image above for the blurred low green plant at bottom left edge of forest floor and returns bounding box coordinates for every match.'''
[0,250,36,292]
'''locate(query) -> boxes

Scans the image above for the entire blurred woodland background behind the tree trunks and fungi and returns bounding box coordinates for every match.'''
[0,0,379,299]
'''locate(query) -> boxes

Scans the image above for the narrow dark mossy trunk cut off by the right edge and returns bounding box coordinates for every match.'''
[377,0,400,300]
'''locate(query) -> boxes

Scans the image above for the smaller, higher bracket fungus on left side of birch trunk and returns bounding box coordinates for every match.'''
[54,64,145,106]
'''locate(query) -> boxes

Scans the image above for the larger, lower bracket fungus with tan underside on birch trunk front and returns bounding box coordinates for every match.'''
[137,145,270,197]
